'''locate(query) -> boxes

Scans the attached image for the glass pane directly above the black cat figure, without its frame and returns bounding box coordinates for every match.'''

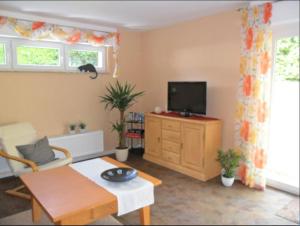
[69,49,103,67]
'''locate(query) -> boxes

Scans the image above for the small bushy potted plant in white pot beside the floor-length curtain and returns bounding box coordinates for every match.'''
[217,149,242,187]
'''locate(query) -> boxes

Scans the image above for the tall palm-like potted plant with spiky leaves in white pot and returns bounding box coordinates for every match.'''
[100,80,144,162]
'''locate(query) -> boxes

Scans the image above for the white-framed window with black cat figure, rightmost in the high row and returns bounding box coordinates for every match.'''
[66,45,105,72]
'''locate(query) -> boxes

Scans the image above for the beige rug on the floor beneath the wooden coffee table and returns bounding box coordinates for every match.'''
[0,210,122,225]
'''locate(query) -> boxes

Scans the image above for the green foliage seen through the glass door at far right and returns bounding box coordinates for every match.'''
[275,36,299,81]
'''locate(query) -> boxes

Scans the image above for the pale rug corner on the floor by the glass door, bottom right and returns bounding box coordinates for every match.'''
[277,198,300,224]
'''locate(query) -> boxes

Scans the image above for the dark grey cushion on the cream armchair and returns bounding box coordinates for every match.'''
[16,137,55,165]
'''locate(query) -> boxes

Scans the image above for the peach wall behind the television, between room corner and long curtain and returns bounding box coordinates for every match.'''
[142,12,241,148]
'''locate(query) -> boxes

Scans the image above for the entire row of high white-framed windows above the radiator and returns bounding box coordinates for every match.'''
[0,37,106,73]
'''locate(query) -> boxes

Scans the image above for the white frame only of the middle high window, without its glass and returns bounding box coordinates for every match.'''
[11,39,64,72]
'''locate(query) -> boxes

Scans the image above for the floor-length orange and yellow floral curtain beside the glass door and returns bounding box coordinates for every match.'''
[235,3,272,190]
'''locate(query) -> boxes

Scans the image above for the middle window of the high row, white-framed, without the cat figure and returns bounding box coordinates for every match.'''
[12,40,64,71]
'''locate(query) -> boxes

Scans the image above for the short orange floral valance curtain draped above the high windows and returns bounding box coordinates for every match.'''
[0,16,120,77]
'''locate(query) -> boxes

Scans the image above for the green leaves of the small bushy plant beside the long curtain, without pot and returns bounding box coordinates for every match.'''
[216,149,244,178]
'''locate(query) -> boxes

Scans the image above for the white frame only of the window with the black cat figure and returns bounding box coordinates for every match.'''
[64,44,106,73]
